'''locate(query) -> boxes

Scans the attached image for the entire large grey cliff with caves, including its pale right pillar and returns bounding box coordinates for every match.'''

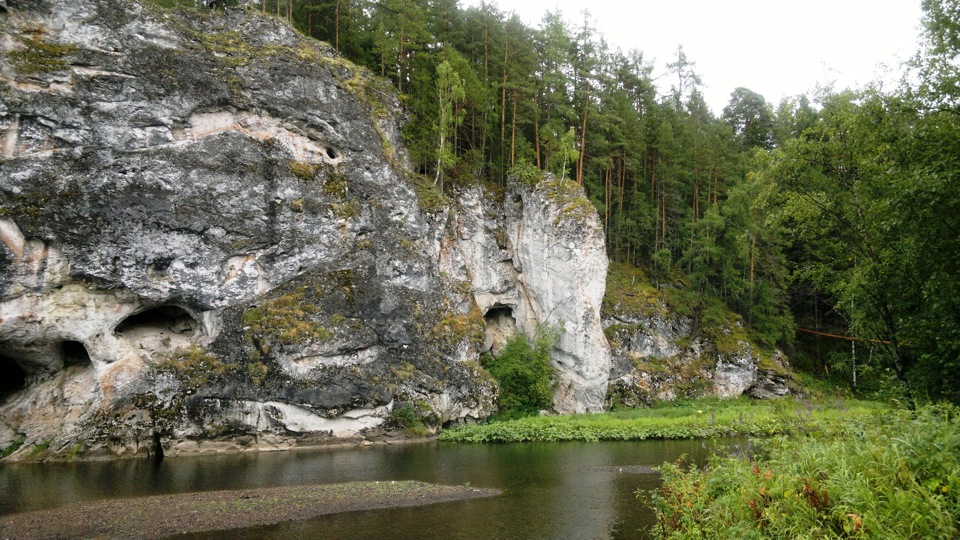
[0,0,610,460]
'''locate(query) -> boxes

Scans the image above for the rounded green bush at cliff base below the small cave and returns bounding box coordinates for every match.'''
[481,325,560,415]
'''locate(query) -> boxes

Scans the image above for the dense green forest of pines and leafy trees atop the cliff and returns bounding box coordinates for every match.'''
[178,0,960,401]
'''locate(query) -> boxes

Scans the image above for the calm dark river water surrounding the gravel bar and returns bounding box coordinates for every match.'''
[0,441,732,539]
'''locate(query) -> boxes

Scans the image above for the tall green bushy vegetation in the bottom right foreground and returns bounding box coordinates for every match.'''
[652,405,960,539]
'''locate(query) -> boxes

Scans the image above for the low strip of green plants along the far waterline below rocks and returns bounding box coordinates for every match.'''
[440,398,886,443]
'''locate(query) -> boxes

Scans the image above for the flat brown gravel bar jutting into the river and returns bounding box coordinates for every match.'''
[0,481,500,539]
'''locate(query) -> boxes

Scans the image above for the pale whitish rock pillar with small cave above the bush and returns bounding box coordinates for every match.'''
[441,179,610,413]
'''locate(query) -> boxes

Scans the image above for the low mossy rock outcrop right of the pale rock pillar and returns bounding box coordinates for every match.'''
[603,268,792,407]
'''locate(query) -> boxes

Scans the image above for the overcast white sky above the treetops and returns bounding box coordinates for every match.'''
[460,0,921,115]
